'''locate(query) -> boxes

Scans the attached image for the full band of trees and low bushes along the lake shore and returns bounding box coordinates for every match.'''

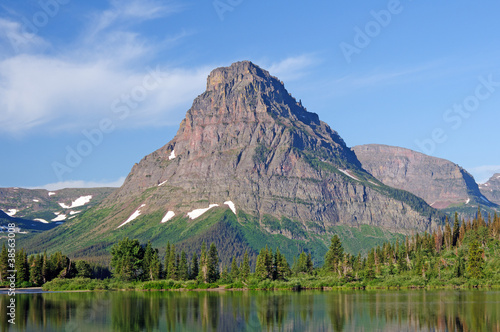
[0,209,500,291]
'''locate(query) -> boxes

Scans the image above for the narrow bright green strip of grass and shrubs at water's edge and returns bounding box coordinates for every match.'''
[42,277,500,291]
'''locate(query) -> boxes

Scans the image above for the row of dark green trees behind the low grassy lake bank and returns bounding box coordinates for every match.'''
[4,209,500,286]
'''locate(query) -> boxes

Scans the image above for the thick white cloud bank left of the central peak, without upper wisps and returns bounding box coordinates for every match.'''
[0,55,209,134]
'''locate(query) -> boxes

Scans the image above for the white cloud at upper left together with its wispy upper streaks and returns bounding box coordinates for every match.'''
[0,0,210,136]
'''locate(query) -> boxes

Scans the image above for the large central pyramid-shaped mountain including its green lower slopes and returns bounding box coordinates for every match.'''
[17,61,443,259]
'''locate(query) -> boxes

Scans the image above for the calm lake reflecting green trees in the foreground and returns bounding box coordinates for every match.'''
[0,290,500,332]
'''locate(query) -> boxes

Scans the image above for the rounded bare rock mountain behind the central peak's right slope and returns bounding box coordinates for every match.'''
[353,144,492,209]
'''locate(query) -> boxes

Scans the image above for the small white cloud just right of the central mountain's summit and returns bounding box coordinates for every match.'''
[264,54,319,82]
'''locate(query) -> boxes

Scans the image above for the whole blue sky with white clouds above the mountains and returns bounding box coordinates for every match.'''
[0,0,500,189]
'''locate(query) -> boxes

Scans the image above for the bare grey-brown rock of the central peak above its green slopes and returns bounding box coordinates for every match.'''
[103,61,442,236]
